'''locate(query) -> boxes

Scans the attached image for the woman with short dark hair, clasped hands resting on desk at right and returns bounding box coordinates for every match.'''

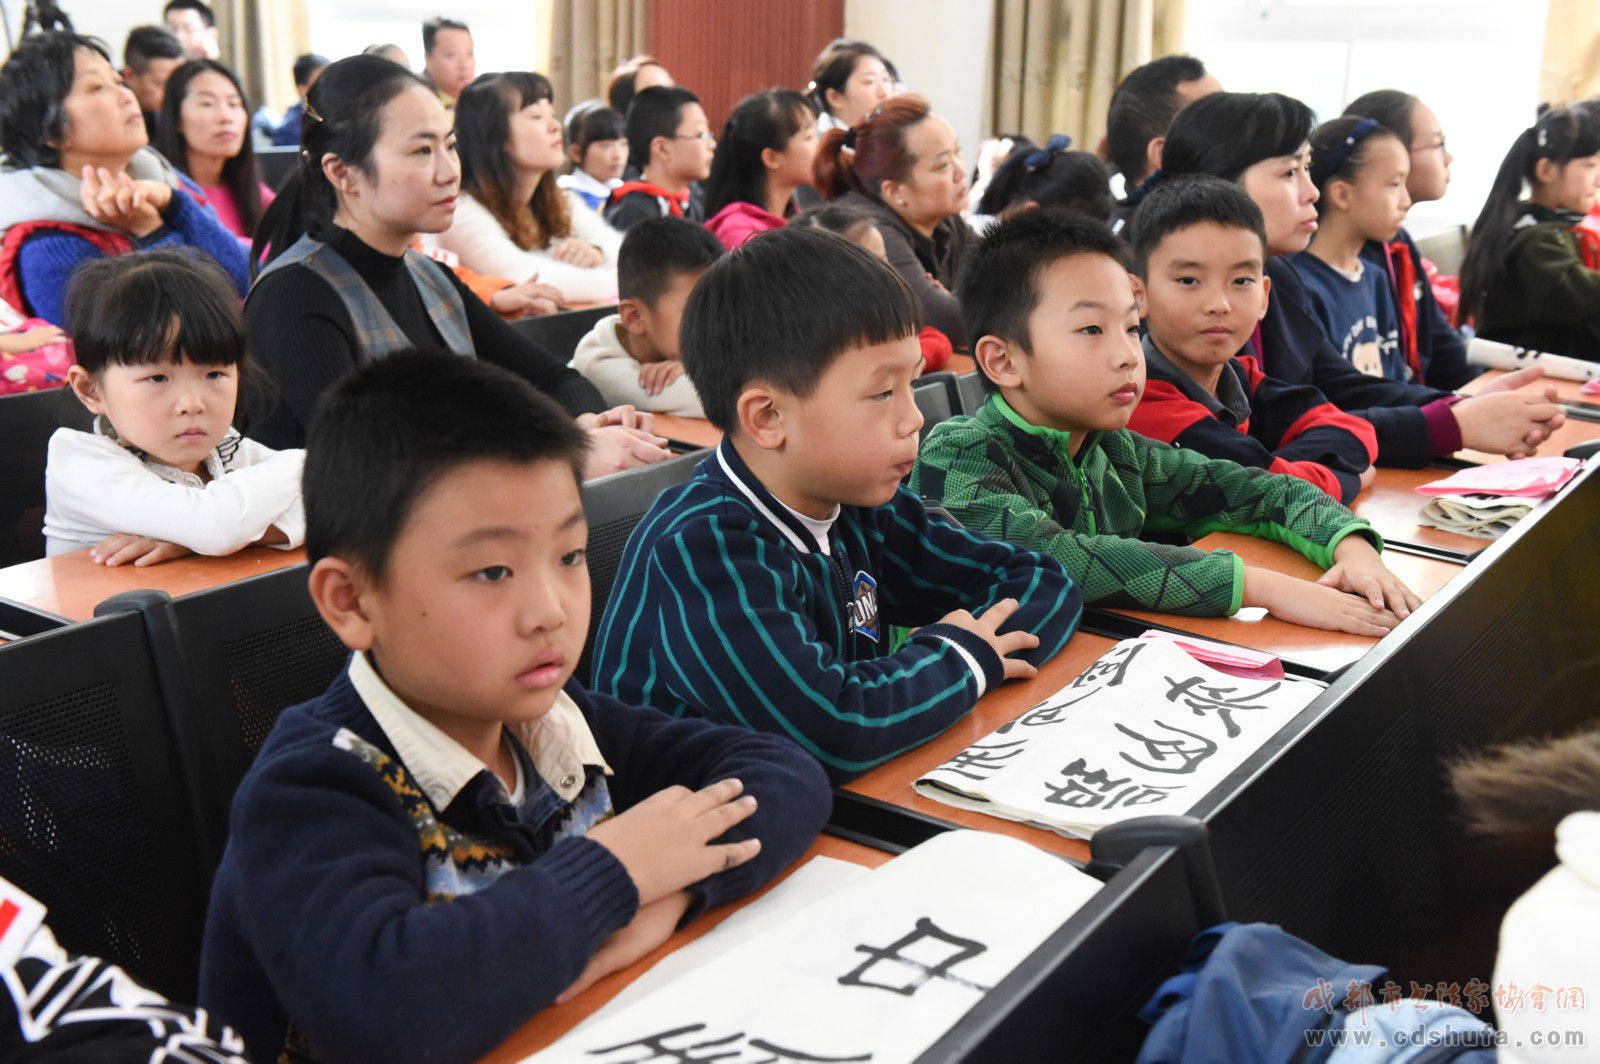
[1162,93,1562,467]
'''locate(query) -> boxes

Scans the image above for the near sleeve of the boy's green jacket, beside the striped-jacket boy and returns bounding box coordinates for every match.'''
[910,418,1243,616]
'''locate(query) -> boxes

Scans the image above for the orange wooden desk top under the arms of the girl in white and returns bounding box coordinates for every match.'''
[0,547,306,621]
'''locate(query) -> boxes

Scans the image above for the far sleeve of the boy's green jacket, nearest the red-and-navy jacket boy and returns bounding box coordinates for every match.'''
[1123,432,1382,570]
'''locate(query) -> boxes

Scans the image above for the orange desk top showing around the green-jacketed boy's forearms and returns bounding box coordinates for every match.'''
[1118,533,1462,670]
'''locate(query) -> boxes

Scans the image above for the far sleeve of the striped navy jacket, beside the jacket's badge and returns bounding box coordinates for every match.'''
[869,488,1083,666]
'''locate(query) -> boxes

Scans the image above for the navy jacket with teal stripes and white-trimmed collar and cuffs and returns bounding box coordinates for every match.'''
[592,440,1083,784]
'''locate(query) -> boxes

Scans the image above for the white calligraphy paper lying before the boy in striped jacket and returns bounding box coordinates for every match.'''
[915,638,1323,838]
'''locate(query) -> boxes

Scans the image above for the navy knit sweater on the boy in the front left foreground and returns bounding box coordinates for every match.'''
[200,674,832,1061]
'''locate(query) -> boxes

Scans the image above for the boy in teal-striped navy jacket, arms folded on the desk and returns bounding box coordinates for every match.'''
[594,229,1082,782]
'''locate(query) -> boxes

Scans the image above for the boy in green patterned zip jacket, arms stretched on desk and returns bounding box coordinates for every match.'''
[912,211,1418,635]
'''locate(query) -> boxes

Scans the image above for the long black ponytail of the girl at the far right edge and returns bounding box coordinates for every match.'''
[1461,106,1600,320]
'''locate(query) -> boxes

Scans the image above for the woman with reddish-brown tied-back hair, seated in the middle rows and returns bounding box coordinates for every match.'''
[811,94,978,347]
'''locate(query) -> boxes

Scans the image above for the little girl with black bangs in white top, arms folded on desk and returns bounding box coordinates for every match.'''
[45,251,306,565]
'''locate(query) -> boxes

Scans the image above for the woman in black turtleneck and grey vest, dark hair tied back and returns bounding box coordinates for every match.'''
[245,56,667,475]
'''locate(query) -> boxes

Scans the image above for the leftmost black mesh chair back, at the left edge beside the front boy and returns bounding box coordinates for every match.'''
[0,613,205,1002]
